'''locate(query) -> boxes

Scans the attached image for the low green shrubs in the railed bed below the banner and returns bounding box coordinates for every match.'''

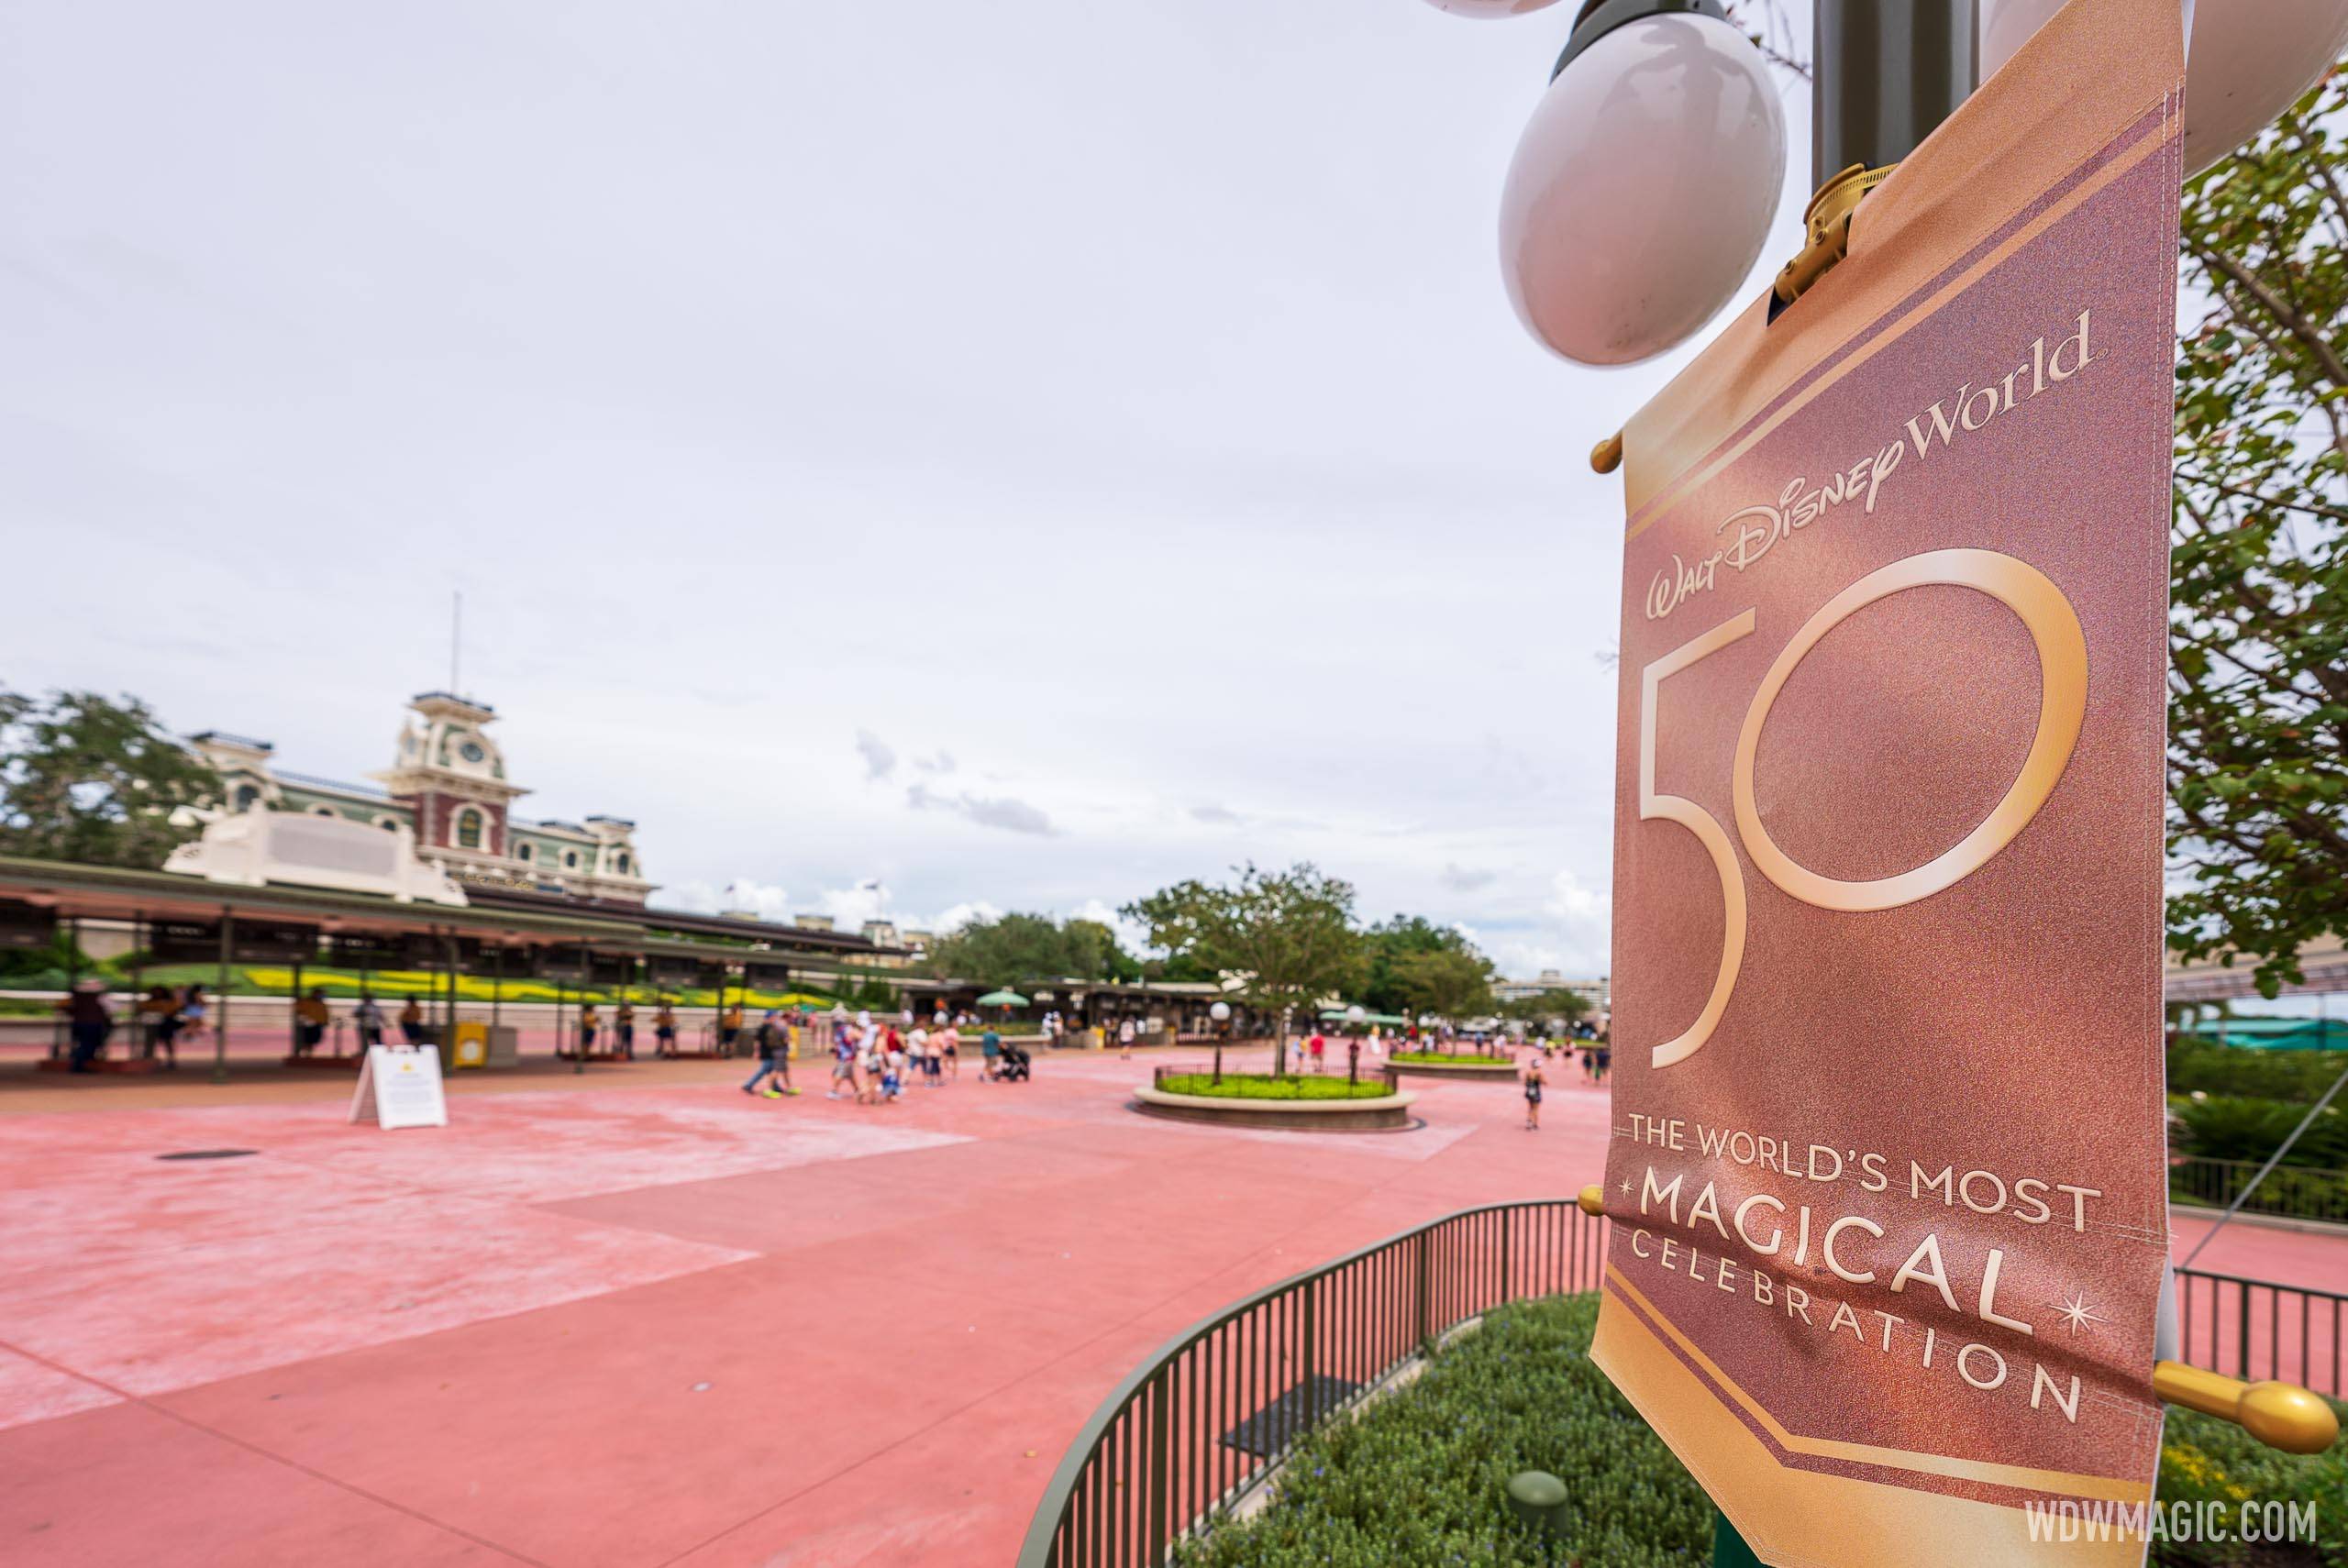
[1174,1296,2348,1568]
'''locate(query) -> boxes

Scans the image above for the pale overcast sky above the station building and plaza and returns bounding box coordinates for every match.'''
[0,0,1808,974]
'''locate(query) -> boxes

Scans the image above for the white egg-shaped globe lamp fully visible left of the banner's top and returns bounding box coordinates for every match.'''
[1501,0,1785,364]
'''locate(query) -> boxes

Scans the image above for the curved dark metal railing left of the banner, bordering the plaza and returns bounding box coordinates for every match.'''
[1019,1198,1606,1568]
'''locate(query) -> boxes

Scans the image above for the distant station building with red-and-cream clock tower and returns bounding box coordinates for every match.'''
[188,692,655,906]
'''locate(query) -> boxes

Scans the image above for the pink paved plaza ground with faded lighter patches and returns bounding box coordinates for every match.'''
[0,1056,2348,1568]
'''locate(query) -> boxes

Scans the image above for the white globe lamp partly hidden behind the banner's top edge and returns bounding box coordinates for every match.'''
[1979,0,2348,173]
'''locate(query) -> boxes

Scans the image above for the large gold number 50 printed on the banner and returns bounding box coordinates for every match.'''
[1639,549,2088,1068]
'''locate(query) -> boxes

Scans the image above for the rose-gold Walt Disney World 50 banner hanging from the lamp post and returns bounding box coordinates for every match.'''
[1597,0,2184,1568]
